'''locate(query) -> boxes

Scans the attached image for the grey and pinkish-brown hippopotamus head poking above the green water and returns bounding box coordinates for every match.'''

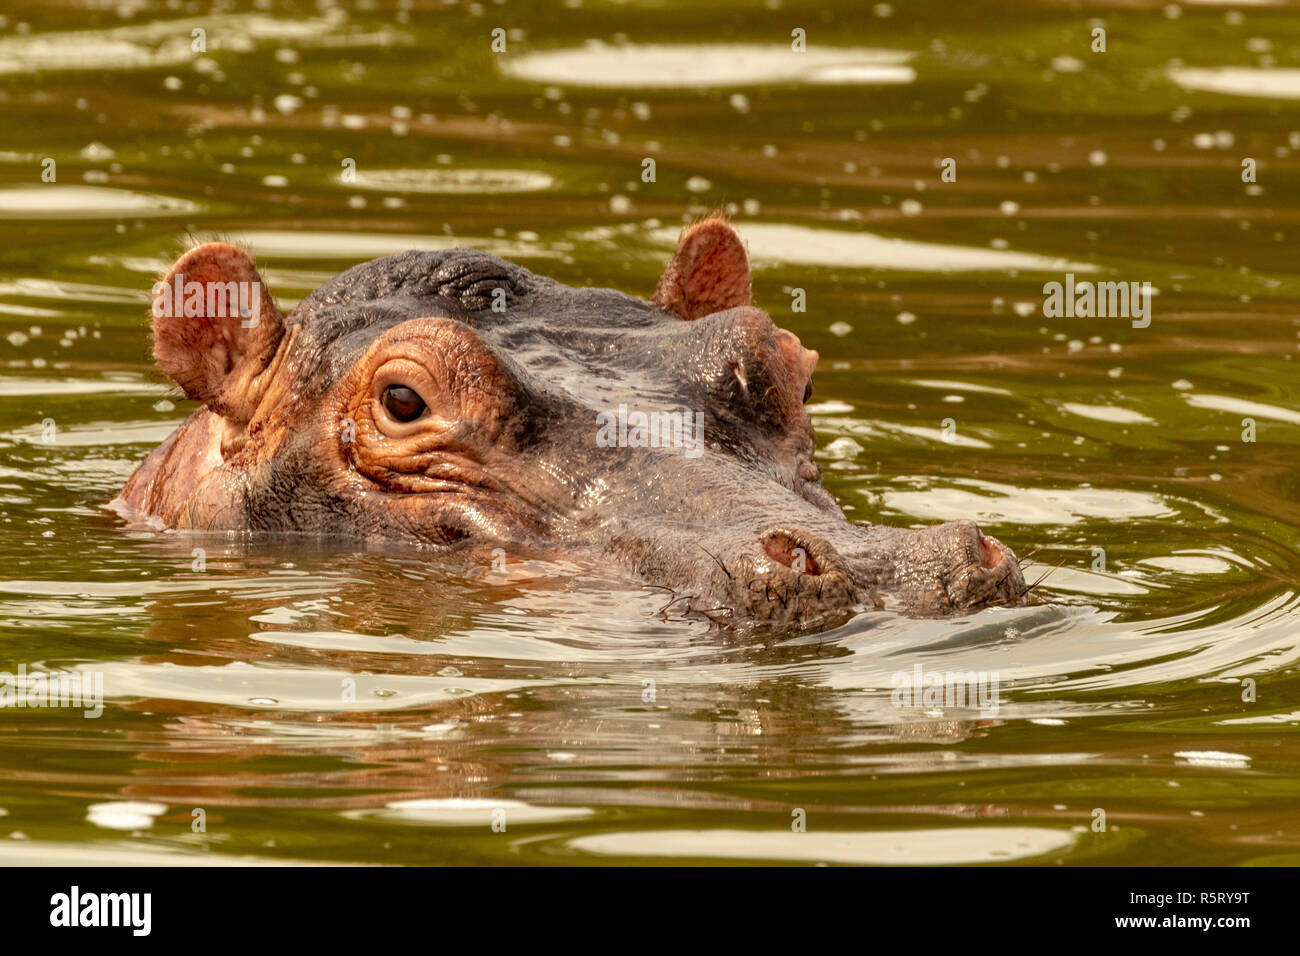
[111,216,1027,628]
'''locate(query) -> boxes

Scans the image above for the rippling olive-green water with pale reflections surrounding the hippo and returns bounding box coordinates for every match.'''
[0,0,1300,864]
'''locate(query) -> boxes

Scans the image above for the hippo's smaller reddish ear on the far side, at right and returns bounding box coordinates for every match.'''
[651,217,750,319]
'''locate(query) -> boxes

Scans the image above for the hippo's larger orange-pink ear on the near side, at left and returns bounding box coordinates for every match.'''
[153,242,285,423]
